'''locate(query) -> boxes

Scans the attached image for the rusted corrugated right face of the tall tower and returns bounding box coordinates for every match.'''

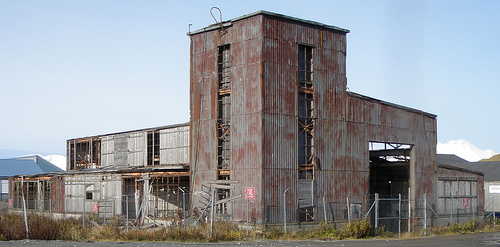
[263,16,346,223]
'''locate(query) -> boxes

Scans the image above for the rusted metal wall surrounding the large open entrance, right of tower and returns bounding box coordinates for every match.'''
[346,93,437,219]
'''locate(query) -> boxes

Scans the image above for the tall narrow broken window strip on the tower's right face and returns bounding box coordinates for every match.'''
[298,45,314,179]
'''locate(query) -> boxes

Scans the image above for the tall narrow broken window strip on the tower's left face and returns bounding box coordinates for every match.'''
[217,45,231,180]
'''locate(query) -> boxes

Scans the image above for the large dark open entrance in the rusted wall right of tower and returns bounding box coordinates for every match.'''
[369,142,412,232]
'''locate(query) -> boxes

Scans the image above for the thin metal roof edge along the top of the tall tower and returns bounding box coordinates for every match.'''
[187,10,350,36]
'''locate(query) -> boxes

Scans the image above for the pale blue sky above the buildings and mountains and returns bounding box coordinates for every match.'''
[0,0,500,158]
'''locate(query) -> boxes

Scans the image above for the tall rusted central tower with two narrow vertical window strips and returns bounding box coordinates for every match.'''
[189,11,349,223]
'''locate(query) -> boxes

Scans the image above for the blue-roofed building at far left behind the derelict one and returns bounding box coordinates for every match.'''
[0,155,63,200]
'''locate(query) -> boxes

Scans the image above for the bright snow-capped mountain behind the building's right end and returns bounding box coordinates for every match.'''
[437,139,497,162]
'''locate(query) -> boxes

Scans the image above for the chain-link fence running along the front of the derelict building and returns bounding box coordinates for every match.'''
[9,188,486,233]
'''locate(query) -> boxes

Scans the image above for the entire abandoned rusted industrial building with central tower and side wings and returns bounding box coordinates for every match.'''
[10,11,484,230]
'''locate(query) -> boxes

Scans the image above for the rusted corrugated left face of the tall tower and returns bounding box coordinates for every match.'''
[190,13,263,220]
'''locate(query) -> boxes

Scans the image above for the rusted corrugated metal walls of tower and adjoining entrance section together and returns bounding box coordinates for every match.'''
[190,12,436,223]
